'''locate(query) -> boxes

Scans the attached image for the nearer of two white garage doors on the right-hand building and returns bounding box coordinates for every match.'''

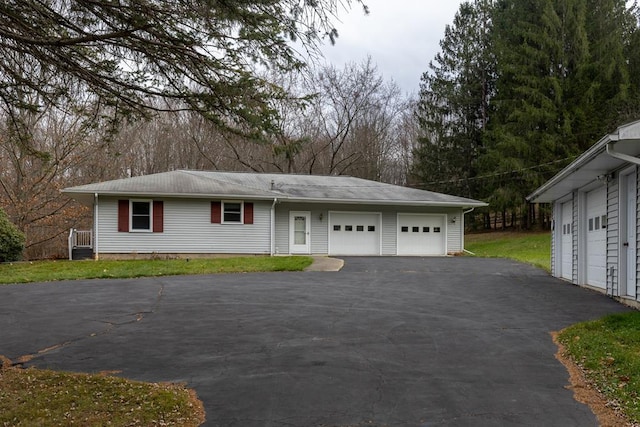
[586,187,607,289]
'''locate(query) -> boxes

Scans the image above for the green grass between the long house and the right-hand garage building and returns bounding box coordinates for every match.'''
[465,231,551,271]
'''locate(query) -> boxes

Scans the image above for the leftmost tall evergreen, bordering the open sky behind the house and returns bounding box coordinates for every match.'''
[414,0,494,197]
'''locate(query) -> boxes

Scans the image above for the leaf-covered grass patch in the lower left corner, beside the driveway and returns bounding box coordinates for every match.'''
[0,364,204,427]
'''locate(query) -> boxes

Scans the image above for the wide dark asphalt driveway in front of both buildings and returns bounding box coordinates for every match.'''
[0,258,625,427]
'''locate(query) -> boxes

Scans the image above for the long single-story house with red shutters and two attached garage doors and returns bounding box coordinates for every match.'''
[63,170,486,258]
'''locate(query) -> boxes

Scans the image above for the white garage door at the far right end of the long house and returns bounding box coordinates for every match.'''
[398,214,447,255]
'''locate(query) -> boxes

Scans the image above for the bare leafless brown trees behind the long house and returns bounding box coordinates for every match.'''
[0,59,417,259]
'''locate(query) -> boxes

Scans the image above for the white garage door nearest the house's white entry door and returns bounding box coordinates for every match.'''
[329,212,381,255]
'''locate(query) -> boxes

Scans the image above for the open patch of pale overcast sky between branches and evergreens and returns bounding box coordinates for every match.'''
[322,0,462,93]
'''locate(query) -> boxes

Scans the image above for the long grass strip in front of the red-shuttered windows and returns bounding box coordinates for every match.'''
[0,256,313,284]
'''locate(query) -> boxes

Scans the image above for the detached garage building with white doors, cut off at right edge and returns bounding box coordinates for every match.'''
[528,121,640,305]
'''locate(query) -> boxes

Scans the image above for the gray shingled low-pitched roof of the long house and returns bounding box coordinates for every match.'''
[62,170,486,207]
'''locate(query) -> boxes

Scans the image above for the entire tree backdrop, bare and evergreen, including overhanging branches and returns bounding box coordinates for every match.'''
[0,0,640,258]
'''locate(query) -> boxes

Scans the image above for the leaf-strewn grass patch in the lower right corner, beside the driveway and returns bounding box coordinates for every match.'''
[558,311,640,425]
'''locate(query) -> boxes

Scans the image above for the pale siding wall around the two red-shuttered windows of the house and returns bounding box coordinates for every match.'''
[97,198,271,254]
